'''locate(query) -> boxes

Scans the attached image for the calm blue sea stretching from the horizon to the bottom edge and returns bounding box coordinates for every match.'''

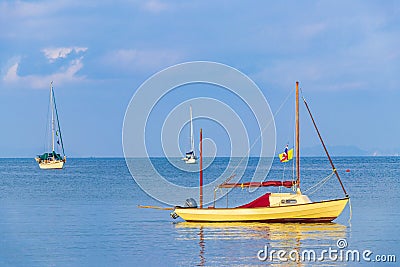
[0,157,400,266]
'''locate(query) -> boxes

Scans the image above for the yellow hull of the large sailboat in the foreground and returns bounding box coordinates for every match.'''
[175,197,349,222]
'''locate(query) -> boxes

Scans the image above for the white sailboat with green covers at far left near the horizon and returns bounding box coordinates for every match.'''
[35,82,67,169]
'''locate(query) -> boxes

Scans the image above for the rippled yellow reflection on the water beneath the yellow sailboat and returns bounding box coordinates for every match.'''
[175,222,347,266]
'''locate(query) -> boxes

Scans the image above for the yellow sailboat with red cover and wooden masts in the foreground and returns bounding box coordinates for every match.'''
[171,82,349,222]
